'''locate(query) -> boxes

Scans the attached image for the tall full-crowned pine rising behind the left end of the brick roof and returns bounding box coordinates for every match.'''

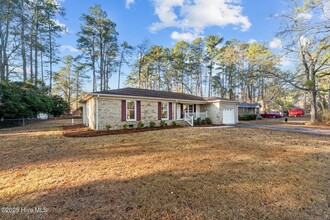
[78,4,118,91]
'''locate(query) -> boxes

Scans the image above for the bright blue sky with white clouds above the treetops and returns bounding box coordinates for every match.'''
[59,0,286,90]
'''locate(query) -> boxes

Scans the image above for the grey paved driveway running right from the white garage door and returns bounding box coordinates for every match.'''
[237,124,330,136]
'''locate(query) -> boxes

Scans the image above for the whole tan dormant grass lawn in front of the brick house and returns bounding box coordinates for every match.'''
[0,124,330,219]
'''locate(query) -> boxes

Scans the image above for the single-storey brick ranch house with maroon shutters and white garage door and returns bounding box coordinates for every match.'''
[81,88,239,130]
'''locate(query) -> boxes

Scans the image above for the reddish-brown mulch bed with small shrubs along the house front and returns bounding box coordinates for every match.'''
[63,125,183,137]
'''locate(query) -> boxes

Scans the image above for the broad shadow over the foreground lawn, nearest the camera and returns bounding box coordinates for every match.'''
[2,165,327,219]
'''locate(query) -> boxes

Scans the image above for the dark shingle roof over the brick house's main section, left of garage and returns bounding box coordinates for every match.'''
[94,88,205,101]
